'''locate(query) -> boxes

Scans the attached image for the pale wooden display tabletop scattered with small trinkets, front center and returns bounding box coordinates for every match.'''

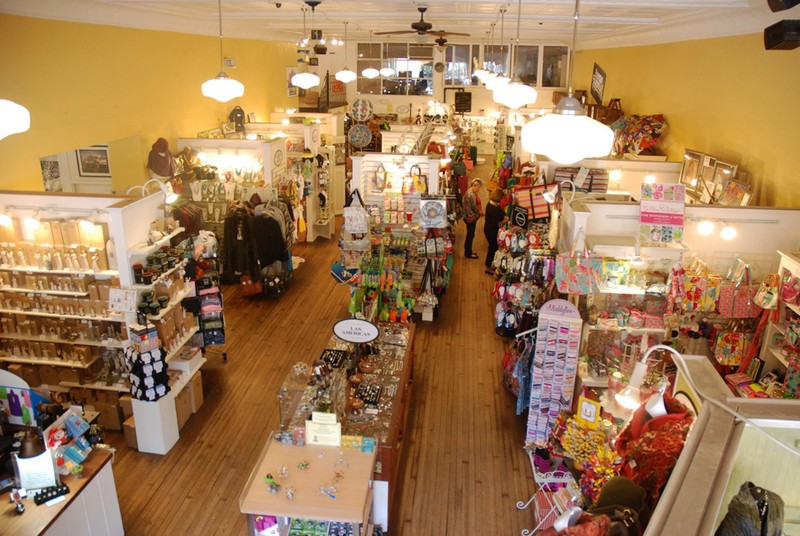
[239,437,377,534]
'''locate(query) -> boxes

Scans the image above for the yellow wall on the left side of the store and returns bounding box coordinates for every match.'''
[0,14,297,192]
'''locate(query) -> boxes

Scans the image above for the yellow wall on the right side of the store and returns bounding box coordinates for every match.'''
[575,34,800,207]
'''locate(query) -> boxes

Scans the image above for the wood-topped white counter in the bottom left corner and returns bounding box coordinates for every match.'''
[0,449,124,536]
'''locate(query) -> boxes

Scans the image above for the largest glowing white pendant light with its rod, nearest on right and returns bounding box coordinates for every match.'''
[521,0,614,164]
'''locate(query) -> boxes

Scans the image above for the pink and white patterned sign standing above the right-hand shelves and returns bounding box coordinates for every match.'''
[639,182,686,244]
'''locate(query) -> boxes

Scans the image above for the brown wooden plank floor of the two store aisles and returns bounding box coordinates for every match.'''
[106,213,534,536]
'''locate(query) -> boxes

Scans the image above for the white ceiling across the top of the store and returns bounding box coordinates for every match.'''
[0,0,800,49]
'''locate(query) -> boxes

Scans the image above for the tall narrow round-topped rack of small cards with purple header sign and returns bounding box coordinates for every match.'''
[526,299,583,443]
